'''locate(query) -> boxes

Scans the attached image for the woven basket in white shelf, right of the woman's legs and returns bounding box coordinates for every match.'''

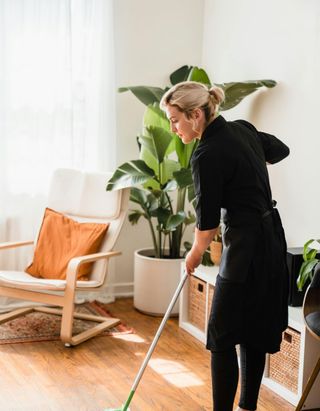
[269,327,300,393]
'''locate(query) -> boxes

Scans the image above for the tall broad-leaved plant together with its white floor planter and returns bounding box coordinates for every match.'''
[107,66,276,315]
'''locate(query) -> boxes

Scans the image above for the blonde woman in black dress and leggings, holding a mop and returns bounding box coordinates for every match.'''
[161,81,289,411]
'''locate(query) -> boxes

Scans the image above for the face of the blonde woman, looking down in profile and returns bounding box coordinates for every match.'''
[166,105,199,144]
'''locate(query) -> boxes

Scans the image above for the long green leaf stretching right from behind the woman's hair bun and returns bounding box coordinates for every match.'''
[217,80,277,111]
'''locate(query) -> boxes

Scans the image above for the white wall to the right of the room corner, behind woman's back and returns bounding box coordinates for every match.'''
[202,0,320,246]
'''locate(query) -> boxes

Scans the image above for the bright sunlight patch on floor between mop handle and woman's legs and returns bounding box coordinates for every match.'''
[149,358,204,388]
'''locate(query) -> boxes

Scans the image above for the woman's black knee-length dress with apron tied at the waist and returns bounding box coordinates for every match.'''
[191,116,289,353]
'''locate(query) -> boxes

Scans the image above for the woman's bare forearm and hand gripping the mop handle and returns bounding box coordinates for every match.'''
[186,227,218,275]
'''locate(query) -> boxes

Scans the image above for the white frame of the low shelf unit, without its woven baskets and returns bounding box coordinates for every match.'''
[179,264,320,410]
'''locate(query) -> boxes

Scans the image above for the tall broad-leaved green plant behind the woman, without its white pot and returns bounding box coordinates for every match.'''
[107,62,276,260]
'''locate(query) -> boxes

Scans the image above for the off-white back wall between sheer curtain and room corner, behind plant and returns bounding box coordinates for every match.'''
[114,0,204,294]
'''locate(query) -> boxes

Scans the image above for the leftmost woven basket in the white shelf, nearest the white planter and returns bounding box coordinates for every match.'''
[188,275,206,331]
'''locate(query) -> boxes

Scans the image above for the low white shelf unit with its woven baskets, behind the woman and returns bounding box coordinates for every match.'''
[179,264,320,409]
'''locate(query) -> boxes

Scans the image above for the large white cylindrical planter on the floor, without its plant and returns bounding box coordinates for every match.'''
[133,249,183,316]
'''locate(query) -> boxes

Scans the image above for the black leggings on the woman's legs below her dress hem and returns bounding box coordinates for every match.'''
[211,345,266,411]
